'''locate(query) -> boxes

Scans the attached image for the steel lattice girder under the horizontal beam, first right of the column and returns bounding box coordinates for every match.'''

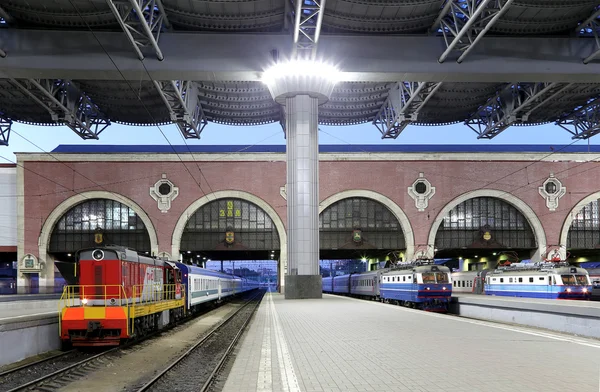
[373,82,442,139]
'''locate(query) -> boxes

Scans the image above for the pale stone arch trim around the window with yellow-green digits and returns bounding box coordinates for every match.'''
[171,190,287,278]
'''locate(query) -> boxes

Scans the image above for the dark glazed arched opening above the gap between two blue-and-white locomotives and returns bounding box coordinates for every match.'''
[434,196,538,271]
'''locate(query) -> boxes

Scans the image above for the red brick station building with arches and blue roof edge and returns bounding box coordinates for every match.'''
[13,145,600,292]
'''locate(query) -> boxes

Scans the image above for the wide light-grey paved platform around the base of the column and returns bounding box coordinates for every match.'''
[223,294,600,392]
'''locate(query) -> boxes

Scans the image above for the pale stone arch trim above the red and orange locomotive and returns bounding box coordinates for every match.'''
[38,191,158,260]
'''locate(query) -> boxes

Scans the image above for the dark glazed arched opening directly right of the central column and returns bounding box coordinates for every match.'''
[319,196,407,277]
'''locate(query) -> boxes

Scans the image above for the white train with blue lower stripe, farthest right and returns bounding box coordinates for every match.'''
[452,262,592,300]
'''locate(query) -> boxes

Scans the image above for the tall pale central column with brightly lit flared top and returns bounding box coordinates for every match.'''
[263,62,336,299]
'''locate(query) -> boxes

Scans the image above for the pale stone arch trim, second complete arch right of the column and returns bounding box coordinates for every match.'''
[427,189,546,262]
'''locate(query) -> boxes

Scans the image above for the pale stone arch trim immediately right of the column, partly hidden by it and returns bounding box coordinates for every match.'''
[319,189,415,260]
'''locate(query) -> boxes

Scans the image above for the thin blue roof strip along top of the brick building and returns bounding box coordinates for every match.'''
[52,144,600,154]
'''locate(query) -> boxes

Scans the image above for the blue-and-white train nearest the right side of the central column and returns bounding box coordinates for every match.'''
[323,261,452,312]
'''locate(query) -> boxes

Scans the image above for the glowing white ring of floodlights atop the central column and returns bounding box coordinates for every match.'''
[262,60,341,84]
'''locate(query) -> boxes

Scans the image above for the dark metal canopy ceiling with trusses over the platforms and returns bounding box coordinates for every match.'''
[0,0,600,144]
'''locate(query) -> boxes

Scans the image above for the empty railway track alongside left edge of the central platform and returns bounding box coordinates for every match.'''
[130,290,265,392]
